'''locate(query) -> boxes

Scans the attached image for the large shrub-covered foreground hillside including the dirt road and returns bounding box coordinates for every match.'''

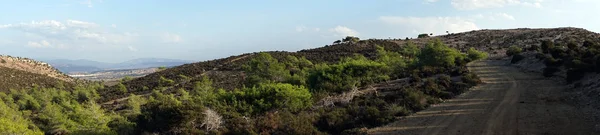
[0,28,600,134]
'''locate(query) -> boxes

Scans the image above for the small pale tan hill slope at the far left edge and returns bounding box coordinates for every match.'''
[0,55,75,91]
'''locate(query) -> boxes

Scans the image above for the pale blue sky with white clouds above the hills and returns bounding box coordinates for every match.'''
[0,0,600,62]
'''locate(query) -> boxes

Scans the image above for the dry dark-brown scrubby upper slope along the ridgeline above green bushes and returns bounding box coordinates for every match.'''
[100,27,600,102]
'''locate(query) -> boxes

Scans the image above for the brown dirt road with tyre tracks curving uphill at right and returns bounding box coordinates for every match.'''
[369,61,600,135]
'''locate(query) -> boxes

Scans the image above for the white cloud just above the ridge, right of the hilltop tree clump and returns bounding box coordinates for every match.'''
[379,16,479,34]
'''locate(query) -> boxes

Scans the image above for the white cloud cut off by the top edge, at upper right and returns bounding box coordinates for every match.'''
[450,0,543,10]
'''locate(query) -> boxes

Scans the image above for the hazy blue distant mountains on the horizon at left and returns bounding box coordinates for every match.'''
[46,58,192,73]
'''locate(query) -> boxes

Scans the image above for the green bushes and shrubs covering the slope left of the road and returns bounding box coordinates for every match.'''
[0,38,486,134]
